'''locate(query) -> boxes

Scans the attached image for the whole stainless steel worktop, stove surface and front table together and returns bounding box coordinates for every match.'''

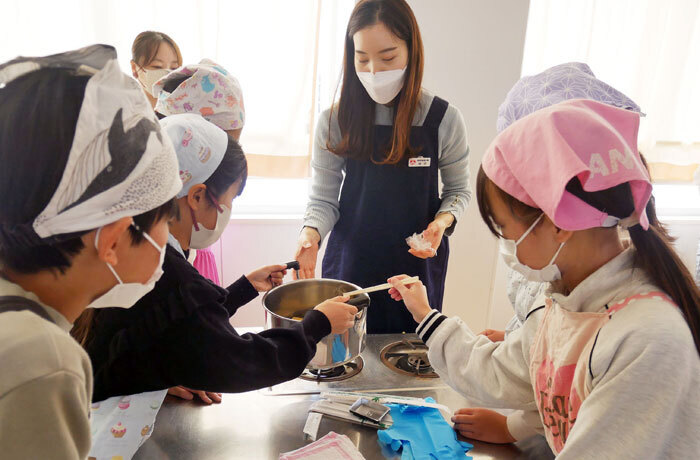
[134,334,554,460]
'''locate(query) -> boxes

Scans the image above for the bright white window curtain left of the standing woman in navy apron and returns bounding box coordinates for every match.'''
[0,0,354,177]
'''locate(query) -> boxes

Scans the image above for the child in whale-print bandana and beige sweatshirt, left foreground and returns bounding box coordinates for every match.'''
[0,45,182,460]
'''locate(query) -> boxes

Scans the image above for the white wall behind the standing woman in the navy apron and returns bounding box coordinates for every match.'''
[219,0,529,330]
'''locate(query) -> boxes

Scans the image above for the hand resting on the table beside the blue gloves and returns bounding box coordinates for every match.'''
[452,408,516,444]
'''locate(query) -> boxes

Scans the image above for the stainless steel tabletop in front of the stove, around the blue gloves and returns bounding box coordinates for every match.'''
[134,390,554,460]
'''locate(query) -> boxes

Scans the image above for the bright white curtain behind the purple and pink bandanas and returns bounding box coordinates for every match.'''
[523,0,700,180]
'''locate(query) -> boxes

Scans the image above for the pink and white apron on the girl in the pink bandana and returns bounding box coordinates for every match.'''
[530,292,673,454]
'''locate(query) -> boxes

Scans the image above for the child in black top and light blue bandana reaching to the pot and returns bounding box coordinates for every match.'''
[75,114,357,403]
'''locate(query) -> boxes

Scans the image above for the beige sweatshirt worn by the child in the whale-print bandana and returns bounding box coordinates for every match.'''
[0,278,92,460]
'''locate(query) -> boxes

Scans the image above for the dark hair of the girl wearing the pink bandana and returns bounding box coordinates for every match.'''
[476,162,700,354]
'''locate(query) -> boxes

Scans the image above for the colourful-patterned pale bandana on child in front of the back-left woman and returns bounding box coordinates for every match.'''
[153,59,245,131]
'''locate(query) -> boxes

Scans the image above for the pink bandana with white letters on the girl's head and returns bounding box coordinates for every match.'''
[482,99,651,230]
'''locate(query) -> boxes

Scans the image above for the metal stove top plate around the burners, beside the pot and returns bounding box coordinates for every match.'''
[260,334,447,395]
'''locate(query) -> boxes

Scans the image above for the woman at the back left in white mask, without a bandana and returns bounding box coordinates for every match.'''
[131,30,182,107]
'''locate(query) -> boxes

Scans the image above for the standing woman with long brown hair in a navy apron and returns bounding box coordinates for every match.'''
[296,0,470,333]
